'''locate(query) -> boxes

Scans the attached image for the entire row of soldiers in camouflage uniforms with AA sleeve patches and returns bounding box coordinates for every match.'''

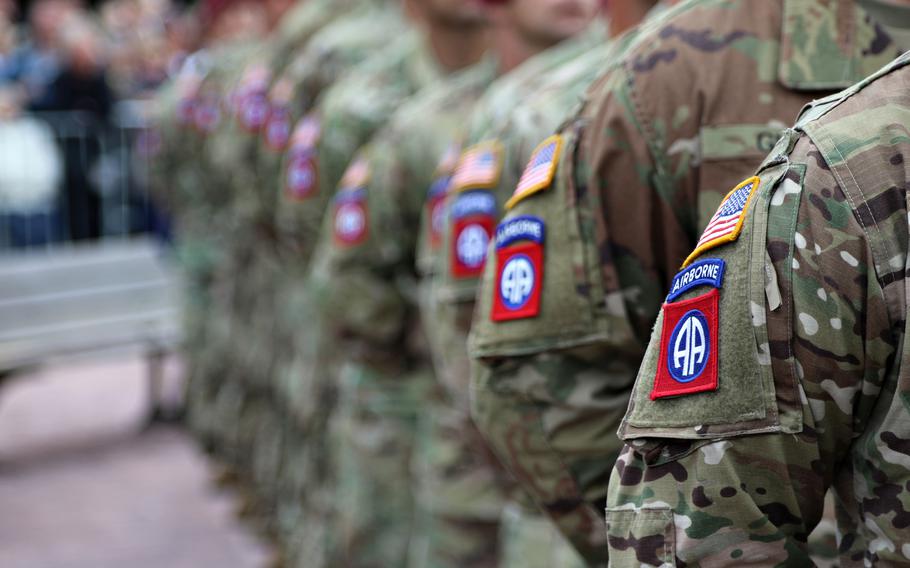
[152,0,910,567]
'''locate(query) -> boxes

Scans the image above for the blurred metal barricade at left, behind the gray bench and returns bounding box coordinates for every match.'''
[0,102,167,253]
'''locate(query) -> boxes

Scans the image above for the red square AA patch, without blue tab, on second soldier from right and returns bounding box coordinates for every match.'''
[491,243,543,321]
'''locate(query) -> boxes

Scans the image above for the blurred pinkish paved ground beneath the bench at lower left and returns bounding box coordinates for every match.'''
[0,358,271,568]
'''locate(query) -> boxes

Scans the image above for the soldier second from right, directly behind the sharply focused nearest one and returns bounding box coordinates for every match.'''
[470,0,899,563]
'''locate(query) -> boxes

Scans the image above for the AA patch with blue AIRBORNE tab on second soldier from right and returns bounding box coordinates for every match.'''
[490,215,546,322]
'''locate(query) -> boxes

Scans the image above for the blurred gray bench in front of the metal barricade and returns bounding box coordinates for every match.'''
[0,238,180,418]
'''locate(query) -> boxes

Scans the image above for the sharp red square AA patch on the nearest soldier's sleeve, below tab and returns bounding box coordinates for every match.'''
[651,289,720,400]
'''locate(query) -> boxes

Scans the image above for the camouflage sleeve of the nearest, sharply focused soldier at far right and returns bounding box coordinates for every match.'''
[607,133,905,566]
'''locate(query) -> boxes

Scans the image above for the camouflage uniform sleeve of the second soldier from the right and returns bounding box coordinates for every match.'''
[471,62,691,565]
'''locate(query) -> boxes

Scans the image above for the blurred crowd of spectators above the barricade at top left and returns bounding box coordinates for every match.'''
[0,0,198,116]
